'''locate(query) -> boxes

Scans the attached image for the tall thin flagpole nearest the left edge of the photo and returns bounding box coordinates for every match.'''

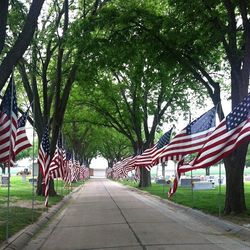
[6,72,14,241]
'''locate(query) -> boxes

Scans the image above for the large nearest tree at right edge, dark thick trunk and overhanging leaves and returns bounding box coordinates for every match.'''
[127,0,250,213]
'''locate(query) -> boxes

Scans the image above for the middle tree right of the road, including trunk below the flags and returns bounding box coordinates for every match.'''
[71,6,200,186]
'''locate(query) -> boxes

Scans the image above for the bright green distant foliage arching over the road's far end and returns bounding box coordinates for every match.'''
[63,83,131,167]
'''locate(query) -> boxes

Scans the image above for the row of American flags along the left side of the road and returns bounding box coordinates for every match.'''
[0,78,89,206]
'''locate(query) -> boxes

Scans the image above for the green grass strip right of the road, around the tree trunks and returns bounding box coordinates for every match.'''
[117,180,250,224]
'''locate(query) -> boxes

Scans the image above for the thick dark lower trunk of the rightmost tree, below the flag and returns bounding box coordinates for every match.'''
[224,143,248,214]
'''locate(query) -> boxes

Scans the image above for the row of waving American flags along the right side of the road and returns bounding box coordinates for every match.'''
[107,96,250,196]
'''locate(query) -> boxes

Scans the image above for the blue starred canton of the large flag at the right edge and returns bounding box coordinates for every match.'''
[226,96,250,131]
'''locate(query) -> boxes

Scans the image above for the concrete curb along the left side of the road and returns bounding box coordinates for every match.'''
[0,185,82,250]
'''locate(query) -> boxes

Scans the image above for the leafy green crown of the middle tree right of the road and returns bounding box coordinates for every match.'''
[68,1,203,154]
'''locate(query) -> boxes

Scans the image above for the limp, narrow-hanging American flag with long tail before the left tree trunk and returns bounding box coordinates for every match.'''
[38,126,50,207]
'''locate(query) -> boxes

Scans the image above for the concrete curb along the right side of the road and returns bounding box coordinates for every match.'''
[122,183,250,242]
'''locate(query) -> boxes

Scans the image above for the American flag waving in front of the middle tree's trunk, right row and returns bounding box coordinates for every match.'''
[135,129,172,170]
